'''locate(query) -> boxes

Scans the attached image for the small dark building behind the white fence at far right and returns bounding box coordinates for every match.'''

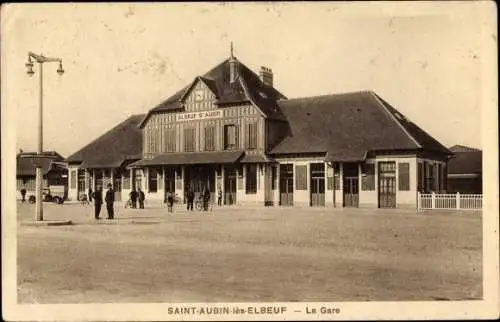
[447,145,483,194]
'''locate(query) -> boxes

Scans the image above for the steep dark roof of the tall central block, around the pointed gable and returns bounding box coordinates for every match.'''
[140,59,286,126]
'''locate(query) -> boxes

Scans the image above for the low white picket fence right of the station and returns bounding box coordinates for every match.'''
[417,192,483,210]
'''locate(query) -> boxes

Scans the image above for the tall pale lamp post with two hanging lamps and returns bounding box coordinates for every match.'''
[26,52,64,221]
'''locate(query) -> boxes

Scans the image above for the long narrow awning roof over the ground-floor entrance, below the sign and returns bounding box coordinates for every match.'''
[128,151,244,168]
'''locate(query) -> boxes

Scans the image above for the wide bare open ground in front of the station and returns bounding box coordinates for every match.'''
[17,203,482,303]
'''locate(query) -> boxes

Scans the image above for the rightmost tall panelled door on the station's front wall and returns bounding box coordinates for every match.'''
[378,162,396,208]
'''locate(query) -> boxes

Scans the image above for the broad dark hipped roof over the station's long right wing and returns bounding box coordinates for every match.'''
[271,91,450,161]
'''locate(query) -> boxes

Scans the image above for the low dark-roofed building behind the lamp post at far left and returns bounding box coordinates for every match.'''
[16,150,68,199]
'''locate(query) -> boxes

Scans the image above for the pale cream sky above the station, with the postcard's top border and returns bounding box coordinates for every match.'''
[1,2,496,157]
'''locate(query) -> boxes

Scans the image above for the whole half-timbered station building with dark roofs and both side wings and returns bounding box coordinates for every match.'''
[67,55,451,208]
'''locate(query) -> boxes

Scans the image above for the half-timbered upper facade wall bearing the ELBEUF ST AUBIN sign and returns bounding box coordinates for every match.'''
[143,81,266,158]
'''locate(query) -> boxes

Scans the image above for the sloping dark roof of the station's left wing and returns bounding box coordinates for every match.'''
[66,114,144,168]
